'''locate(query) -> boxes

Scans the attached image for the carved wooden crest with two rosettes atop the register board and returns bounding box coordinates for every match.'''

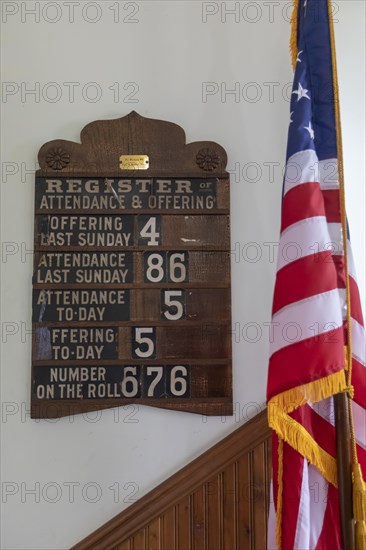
[38,111,228,177]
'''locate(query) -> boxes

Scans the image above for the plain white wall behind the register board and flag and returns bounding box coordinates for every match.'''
[1,0,365,550]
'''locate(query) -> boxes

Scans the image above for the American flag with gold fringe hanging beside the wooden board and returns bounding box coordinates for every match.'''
[267,0,366,550]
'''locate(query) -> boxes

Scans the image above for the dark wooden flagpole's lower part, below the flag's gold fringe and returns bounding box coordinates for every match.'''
[334,393,355,550]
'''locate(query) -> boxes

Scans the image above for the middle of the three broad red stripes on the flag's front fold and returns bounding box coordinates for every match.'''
[272,251,344,315]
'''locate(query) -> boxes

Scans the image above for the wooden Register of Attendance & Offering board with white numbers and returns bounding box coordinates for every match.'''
[32,112,232,418]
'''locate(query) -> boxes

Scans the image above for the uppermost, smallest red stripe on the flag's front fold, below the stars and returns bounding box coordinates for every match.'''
[281,182,325,233]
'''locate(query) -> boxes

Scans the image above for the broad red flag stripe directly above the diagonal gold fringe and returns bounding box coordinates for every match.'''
[267,327,344,400]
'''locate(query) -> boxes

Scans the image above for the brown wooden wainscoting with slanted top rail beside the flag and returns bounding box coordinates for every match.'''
[72,411,271,550]
